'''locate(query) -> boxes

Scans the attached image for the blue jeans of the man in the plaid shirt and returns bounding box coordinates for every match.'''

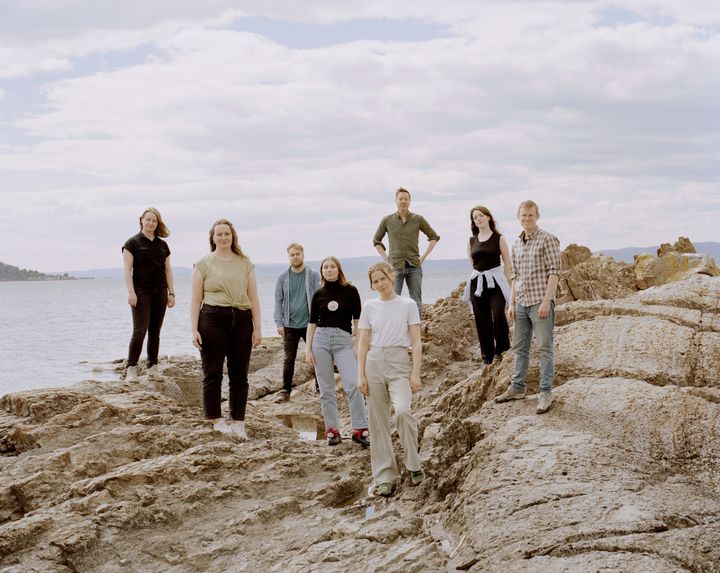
[512,302,555,391]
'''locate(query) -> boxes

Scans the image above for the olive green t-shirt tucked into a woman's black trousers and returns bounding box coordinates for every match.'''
[195,254,255,310]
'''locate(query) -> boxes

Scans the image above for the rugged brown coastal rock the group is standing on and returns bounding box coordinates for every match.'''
[0,274,720,573]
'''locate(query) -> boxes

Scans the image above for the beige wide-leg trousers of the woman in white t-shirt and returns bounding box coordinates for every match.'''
[365,346,421,484]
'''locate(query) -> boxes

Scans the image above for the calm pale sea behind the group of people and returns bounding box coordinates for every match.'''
[0,270,468,396]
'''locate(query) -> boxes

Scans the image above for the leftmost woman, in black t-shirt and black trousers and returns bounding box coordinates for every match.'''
[122,207,175,382]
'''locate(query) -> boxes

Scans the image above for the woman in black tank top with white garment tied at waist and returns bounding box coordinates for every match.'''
[467,206,510,364]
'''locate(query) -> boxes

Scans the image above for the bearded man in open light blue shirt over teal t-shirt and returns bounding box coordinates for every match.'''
[275,243,320,402]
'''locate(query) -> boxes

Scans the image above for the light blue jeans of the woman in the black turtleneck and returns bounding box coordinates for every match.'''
[312,326,368,432]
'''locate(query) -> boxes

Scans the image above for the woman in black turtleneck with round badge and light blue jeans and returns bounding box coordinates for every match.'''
[305,257,370,447]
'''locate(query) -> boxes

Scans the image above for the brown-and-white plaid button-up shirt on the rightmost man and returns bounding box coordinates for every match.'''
[510,227,560,306]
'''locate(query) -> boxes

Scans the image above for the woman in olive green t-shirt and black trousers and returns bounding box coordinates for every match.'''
[190,219,262,439]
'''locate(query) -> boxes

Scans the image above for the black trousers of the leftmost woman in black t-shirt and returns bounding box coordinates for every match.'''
[128,286,168,368]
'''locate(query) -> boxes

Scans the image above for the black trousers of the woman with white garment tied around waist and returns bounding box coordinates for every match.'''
[470,277,510,364]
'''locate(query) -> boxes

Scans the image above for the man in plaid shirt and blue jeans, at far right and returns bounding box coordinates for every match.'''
[495,201,560,414]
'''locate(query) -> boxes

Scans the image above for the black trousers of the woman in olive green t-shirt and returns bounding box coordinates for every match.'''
[198,304,253,420]
